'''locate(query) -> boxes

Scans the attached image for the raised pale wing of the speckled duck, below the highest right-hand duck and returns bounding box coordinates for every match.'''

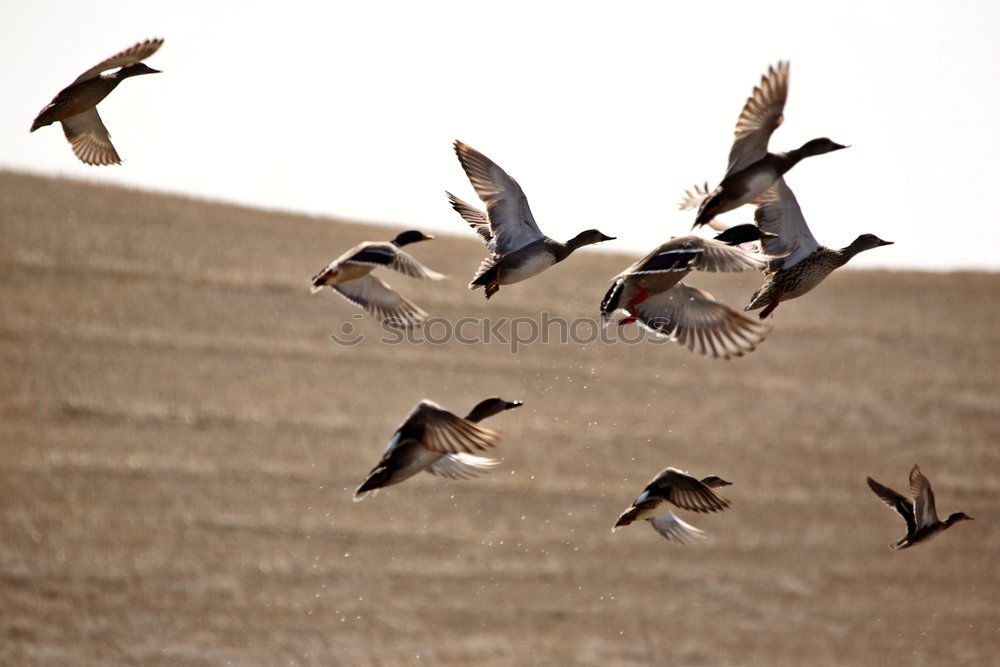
[754,178,820,269]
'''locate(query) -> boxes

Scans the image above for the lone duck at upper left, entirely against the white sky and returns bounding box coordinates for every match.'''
[31,39,163,165]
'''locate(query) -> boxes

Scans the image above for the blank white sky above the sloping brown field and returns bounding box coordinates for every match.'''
[0,0,1000,270]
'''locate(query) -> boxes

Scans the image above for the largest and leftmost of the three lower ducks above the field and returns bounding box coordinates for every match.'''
[354,397,522,502]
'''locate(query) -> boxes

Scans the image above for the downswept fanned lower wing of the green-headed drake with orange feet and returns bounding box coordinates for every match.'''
[635,283,771,360]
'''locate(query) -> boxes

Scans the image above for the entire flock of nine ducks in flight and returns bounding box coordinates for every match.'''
[31,39,973,549]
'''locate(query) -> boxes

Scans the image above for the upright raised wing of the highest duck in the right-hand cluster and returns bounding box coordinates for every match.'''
[726,62,788,176]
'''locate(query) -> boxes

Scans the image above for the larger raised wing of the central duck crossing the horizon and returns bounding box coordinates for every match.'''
[455,141,545,255]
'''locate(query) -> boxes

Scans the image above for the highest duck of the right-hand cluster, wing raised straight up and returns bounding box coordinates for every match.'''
[681,62,847,227]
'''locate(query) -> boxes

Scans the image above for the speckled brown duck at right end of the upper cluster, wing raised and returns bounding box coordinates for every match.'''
[744,178,892,319]
